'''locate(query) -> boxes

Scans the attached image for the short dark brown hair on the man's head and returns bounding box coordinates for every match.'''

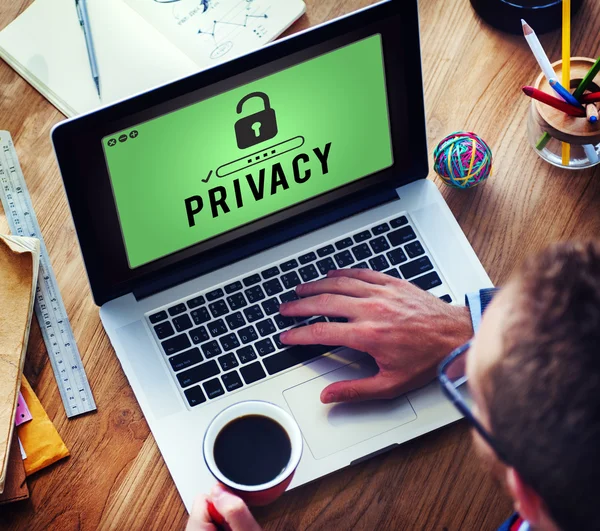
[486,242,600,531]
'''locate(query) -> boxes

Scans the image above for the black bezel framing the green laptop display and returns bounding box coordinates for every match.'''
[52,0,428,305]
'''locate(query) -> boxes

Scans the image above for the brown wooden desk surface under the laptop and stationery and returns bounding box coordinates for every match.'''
[0,0,600,530]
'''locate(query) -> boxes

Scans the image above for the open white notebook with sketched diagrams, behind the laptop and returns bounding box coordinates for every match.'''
[0,0,305,117]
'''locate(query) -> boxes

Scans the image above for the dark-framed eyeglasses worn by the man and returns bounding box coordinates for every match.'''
[438,341,508,463]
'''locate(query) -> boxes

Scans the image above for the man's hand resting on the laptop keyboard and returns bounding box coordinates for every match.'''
[279,269,473,403]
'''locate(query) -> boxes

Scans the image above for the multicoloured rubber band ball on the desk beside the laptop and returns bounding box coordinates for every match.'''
[433,131,492,189]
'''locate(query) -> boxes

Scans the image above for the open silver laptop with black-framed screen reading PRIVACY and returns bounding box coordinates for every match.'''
[52,0,491,510]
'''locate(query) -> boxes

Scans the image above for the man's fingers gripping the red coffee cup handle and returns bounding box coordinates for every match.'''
[185,484,261,531]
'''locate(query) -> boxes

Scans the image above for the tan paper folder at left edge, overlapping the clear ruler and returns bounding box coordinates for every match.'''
[0,236,40,493]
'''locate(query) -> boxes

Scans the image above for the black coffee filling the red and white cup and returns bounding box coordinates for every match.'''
[213,415,292,485]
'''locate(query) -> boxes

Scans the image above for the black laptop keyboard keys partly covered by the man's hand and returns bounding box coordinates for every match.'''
[147,215,452,407]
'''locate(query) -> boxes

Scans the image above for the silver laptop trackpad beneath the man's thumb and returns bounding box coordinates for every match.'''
[283,356,417,459]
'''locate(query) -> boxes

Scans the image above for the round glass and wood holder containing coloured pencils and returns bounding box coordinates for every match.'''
[527,57,600,169]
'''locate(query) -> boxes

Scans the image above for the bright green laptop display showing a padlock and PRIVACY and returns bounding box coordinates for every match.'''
[102,35,392,268]
